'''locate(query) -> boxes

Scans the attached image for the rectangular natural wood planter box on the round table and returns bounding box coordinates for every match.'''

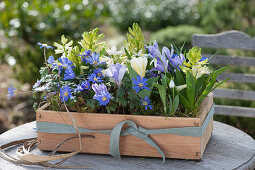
[36,94,213,160]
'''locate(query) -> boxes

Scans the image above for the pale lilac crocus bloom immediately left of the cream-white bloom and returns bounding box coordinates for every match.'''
[105,63,127,87]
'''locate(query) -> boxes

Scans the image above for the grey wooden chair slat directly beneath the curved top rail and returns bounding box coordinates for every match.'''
[202,54,255,66]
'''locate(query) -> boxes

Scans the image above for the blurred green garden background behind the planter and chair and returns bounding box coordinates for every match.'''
[0,0,255,138]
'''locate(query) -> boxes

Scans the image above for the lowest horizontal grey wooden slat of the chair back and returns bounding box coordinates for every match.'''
[215,105,255,118]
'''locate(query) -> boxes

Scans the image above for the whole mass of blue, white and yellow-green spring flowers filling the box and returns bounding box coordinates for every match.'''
[8,24,228,117]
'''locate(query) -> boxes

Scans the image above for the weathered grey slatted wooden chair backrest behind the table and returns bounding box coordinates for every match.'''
[192,31,255,117]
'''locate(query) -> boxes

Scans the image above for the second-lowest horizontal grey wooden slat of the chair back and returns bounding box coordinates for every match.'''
[214,89,255,101]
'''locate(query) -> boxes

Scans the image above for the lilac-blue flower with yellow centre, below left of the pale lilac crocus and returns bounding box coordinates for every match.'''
[92,84,112,106]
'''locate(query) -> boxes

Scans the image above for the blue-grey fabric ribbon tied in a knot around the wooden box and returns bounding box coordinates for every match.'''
[36,104,214,163]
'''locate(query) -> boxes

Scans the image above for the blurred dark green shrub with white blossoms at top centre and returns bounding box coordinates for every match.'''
[108,0,200,31]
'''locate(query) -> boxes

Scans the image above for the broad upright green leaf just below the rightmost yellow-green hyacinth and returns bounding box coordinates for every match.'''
[186,71,196,105]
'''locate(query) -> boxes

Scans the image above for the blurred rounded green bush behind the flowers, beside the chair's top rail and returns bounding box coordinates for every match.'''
[150,25,204,50]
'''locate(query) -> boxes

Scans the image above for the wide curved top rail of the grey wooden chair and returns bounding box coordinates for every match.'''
[192,30,255,51]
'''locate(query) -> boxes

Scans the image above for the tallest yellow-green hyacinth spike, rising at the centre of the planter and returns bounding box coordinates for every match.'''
[124,23,145,55]
